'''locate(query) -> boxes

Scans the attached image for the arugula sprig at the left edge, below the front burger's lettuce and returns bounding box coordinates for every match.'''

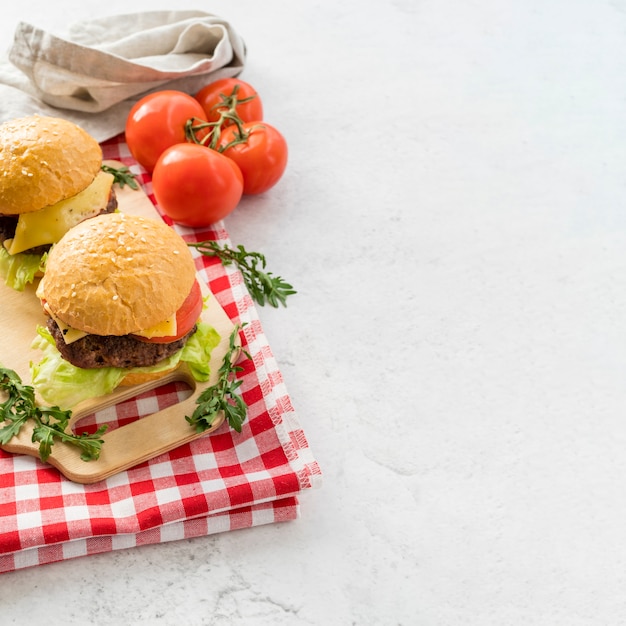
[0,367,107,462]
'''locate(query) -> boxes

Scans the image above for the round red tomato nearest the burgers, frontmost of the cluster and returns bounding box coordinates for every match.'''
[152,143,243,226]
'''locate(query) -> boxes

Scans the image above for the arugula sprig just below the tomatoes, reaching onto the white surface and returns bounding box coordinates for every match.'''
[187,241,298,307]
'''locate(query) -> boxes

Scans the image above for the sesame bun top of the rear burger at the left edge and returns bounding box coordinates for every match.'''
[0,115,102,215]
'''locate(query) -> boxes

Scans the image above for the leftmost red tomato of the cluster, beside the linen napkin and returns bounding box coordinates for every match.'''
[126,89,206,172]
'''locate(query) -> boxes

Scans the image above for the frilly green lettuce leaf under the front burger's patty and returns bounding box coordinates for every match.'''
[30,322,220,409]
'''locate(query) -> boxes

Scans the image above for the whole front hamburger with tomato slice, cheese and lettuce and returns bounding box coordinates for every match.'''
[31,213,220,408]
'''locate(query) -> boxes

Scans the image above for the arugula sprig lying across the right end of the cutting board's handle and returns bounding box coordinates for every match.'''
[185,325,251,433]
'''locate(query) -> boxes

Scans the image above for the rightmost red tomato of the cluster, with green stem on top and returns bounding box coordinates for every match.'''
[220,122,288,194]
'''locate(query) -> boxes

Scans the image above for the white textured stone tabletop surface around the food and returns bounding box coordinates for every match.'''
[0,0,626,626]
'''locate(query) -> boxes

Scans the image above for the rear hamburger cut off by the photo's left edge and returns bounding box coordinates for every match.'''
[0,115,117,291]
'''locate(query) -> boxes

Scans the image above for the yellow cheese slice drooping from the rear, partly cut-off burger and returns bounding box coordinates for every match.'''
[5,171,113,254]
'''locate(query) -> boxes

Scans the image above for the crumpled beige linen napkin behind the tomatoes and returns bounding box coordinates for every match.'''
[0,11,246,141]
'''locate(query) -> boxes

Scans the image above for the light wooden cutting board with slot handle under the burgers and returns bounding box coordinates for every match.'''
[0,161,234,484]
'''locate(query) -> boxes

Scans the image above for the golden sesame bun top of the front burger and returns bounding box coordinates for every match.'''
[38,213,195,336]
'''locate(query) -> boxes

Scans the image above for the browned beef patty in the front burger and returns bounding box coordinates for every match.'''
[47,317,197,369]
